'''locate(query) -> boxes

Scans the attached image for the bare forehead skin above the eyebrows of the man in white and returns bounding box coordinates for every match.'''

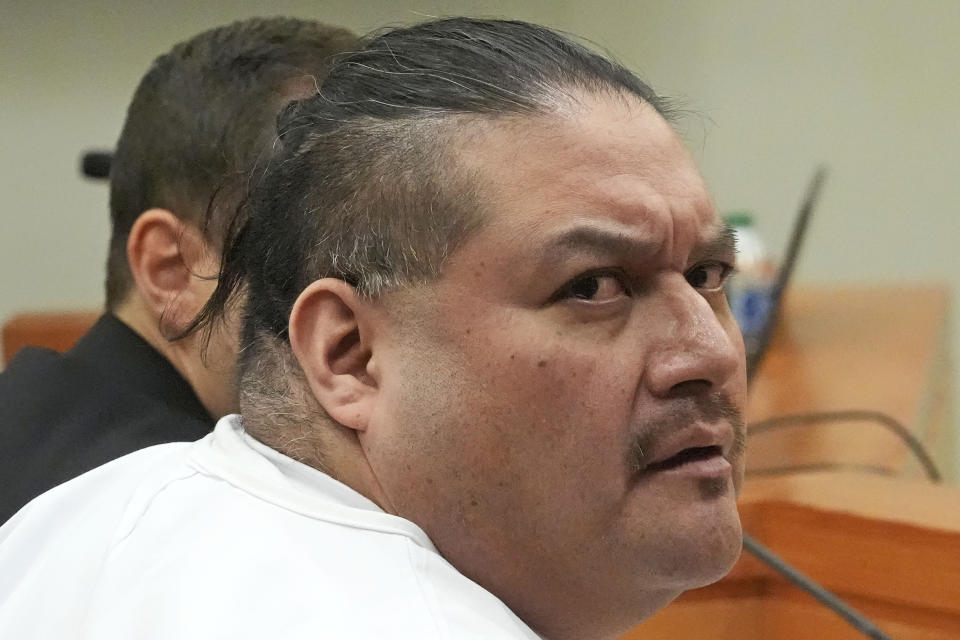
[456,95,706,209]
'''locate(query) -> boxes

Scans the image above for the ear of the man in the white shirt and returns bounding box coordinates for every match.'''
[290,278,378,431]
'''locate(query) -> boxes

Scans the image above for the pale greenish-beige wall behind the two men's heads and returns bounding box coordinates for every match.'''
[0,0,960,470]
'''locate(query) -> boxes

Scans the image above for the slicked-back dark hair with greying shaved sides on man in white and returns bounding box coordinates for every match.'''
[201,18,668,444]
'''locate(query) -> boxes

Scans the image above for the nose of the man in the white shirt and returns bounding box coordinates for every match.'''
[646,278,746,397]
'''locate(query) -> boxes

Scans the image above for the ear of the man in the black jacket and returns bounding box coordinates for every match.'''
[127,209,216,334]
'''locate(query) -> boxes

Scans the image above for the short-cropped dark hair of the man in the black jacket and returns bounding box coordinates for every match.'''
[106,18,358,309]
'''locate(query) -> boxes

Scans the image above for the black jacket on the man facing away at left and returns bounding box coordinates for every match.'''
[0,314,215,523]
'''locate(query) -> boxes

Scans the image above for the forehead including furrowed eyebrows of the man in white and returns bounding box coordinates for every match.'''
[428,96,721,280]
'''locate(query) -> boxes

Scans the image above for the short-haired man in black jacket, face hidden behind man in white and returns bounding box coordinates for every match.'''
[0,18,356,522]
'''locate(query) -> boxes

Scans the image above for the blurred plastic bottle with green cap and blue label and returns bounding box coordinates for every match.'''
[726,211,776,359]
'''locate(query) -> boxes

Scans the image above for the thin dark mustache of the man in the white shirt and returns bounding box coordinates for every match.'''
[627,392,747,472]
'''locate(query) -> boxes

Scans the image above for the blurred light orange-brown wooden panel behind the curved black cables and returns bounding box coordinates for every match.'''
[747,286,956,478]
